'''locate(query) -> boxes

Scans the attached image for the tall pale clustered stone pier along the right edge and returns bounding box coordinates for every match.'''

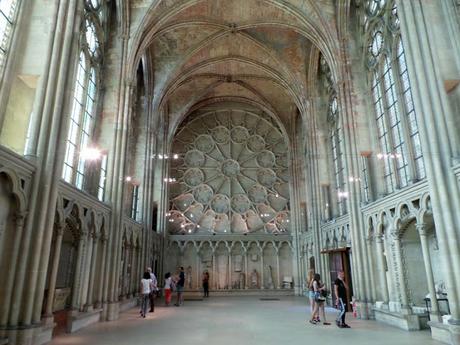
[397,0,460,326]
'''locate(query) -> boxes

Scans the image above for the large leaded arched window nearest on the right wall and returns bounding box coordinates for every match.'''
[363,0,425,193]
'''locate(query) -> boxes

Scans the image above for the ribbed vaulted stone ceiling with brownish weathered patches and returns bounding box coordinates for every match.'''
[129,0,336,137]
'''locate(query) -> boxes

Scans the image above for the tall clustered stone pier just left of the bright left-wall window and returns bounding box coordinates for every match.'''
[23,0,83,326]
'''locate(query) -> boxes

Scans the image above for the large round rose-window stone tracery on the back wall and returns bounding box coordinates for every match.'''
[168,110,290,234]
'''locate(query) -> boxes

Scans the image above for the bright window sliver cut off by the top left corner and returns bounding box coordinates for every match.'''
[0,0,18,76]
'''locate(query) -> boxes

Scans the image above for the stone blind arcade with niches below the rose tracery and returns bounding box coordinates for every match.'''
[165,236,293,292]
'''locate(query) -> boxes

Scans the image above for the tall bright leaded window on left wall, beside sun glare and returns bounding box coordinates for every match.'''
[62,0,107,200]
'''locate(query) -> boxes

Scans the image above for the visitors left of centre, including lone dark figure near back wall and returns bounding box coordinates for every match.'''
[140,267,209,318]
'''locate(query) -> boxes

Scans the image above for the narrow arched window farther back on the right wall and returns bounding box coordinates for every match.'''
[320,58,347,215]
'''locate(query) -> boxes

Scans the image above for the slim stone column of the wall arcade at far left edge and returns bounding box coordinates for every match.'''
[0,214,25,326]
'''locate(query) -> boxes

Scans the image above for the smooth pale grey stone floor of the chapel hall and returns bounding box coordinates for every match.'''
[51,297,441,345]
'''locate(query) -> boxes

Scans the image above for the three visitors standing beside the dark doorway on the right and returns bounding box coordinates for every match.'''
[306,270,350,328]
